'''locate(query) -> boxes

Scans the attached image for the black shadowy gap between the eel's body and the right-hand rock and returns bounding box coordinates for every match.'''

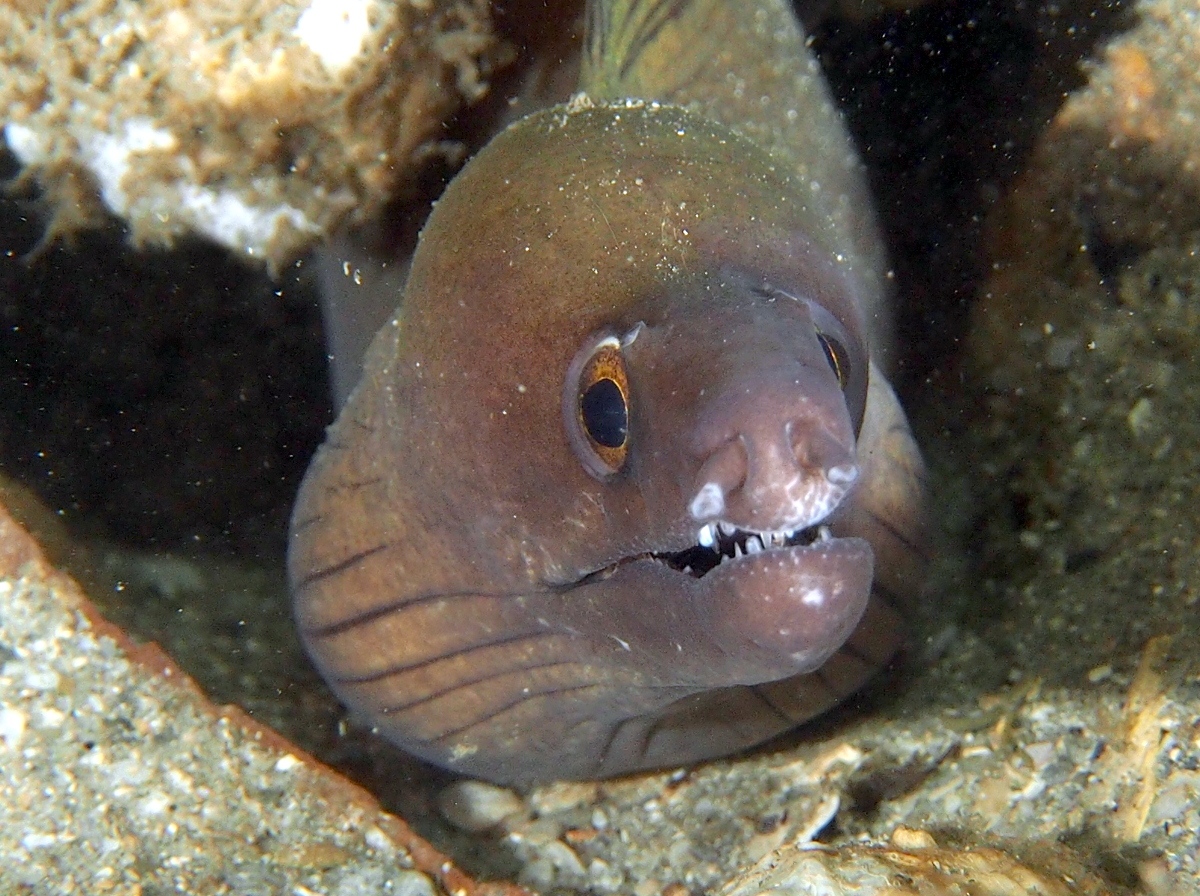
[814,0,1132,391]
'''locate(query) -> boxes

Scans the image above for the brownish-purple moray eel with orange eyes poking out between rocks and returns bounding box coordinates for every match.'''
[289,0,923,784]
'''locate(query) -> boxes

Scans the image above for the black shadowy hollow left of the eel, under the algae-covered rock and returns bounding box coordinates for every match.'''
[0,175,330,564]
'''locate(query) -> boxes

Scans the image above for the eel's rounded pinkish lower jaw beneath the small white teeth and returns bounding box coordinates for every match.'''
[554,527,875,690]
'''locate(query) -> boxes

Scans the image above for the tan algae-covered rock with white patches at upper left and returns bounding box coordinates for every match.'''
[0,0,503,267]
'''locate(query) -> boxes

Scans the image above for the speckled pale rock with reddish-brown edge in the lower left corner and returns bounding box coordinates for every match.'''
[0,509,530,896]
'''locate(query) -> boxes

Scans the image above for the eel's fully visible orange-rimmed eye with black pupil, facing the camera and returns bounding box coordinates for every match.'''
[563,336,629,479]
